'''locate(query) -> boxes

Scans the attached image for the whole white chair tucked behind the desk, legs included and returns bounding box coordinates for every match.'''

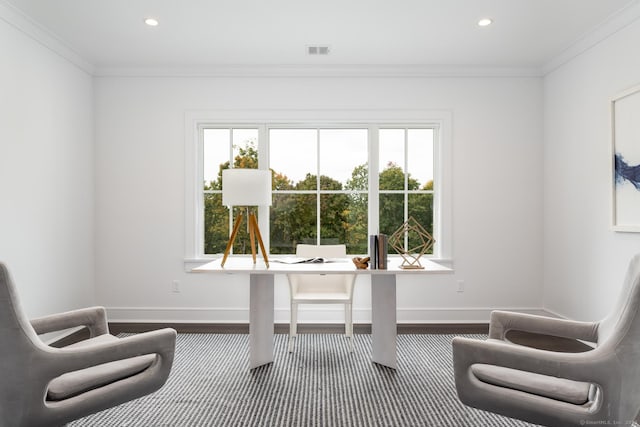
[287,245,356,352]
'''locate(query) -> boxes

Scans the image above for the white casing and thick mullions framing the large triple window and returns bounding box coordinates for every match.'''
[184,110,453,271]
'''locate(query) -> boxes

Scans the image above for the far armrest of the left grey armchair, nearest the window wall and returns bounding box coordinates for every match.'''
[31,307,109,337]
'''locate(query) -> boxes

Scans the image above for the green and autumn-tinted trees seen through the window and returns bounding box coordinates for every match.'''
[204,141,433,254]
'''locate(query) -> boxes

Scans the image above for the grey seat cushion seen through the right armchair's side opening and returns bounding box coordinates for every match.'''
[471,363,591,405]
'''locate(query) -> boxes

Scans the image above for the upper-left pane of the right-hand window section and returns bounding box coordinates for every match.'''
[379,129,405,190]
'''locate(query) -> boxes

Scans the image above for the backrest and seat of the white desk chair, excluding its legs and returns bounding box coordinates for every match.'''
[288,244,355,298]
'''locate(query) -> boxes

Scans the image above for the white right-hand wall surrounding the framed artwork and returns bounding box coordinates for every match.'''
[544,21,640,320]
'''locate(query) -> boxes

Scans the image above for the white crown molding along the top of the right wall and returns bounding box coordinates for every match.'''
[542,0,640,75]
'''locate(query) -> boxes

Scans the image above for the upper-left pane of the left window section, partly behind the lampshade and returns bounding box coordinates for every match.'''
[202,129,231,190]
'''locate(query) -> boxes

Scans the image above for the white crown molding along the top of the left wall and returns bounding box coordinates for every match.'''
[0,0,95,75]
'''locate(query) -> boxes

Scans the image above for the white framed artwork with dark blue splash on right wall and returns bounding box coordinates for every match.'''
[611,86,640,232]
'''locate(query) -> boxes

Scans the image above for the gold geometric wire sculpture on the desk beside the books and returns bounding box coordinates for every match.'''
[389,217,436,269]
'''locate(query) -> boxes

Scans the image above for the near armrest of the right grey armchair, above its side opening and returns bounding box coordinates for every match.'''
[453,337,617,385]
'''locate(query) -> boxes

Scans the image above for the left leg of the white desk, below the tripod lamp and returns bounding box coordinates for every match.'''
[249,274,273,369]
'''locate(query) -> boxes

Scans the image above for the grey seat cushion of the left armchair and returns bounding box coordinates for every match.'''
[47,334,156,400]
